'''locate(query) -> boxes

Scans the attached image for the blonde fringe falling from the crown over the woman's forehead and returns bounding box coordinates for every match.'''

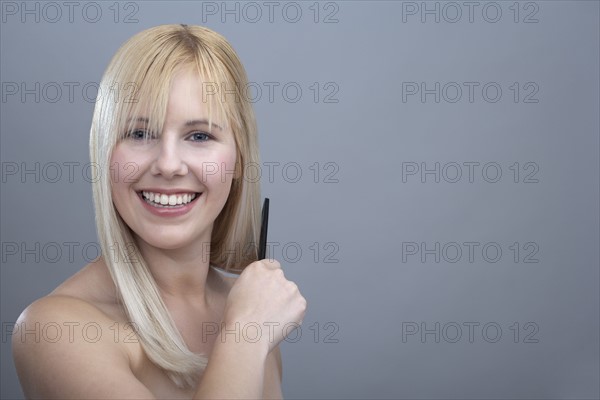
[105,28,236,147]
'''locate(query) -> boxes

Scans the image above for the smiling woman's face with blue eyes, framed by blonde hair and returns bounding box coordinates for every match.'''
[111,70,236,249]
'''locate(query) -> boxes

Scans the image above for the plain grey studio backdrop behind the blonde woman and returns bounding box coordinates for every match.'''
[0,1,600,398]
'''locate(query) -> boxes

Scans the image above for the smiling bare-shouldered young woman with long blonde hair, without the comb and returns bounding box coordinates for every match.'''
[13,25,306,399]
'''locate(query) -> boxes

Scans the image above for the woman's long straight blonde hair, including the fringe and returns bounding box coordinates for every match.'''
[90,25,260,388]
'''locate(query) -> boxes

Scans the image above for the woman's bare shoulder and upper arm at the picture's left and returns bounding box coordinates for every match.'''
[12,260,152,399]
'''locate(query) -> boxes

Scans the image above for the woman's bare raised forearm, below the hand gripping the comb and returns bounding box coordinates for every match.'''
[194,338,268,399]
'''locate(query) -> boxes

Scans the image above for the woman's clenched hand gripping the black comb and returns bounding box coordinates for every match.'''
[224,259,306,352]
